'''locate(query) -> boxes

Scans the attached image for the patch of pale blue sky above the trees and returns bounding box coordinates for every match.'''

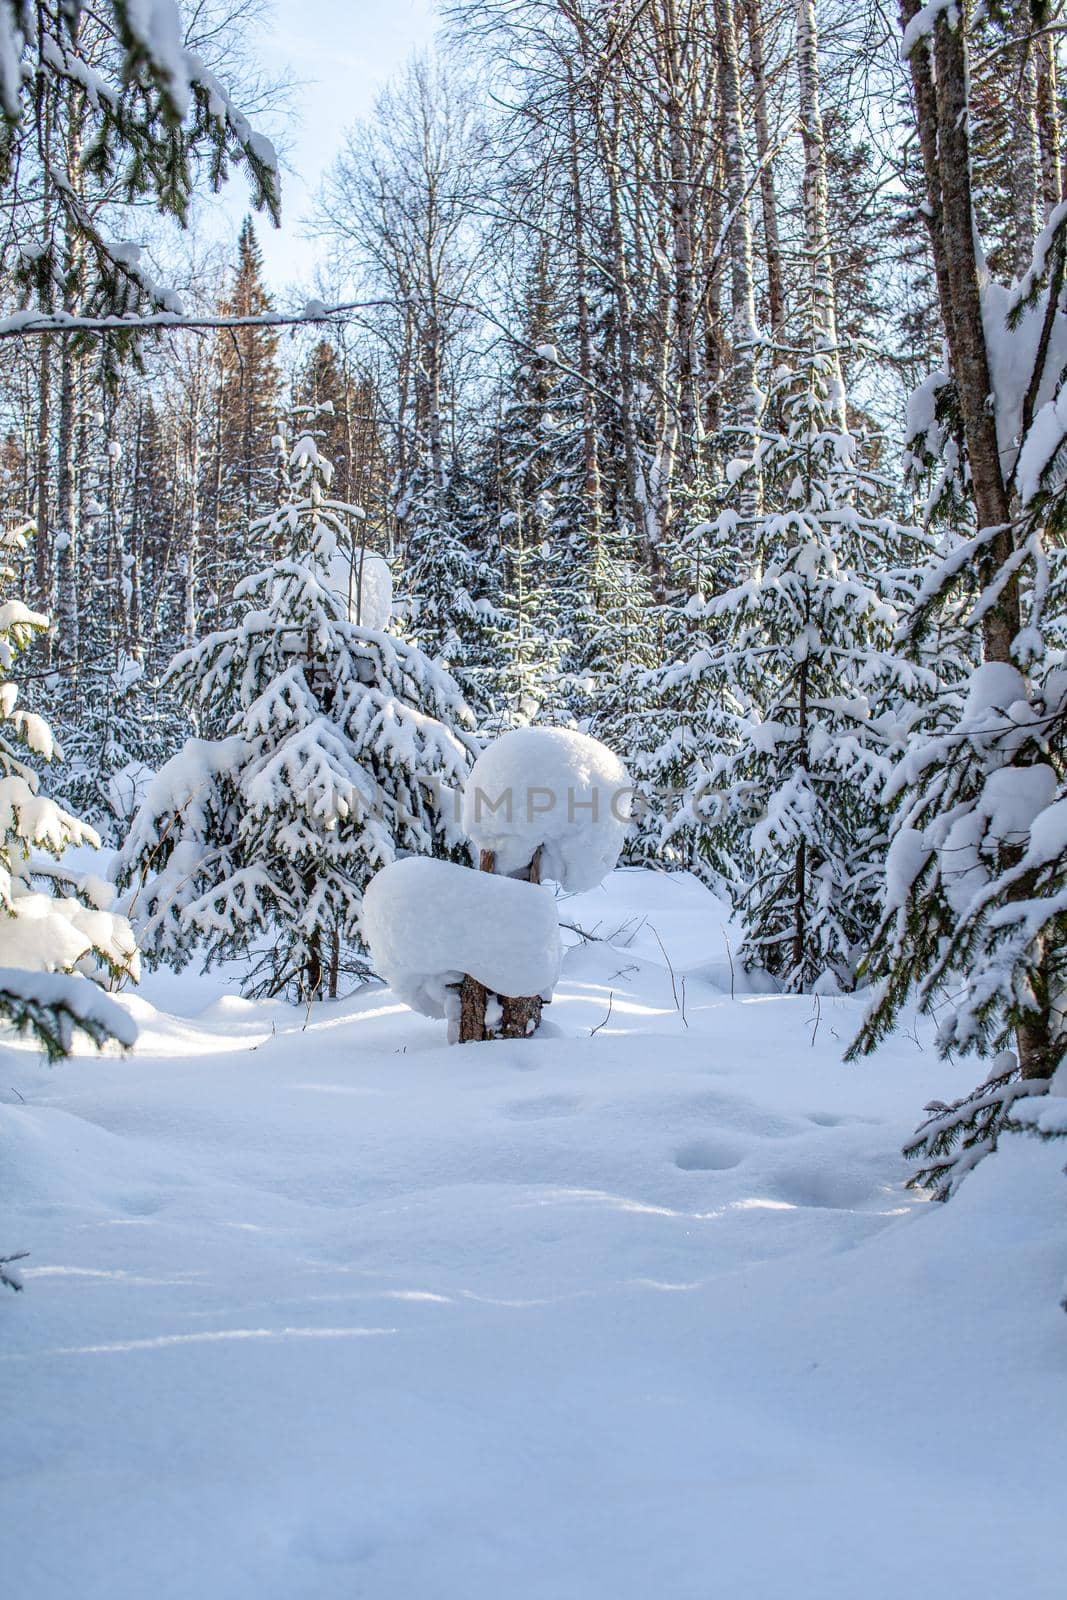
[204,0,435,294]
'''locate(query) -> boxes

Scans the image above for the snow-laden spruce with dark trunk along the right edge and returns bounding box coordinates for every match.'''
[849,0,1067,1198]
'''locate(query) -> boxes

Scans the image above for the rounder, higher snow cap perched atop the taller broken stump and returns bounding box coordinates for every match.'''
[464,728,632,893]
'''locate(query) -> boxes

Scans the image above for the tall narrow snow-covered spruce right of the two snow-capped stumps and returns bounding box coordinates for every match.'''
[657,350,933,990]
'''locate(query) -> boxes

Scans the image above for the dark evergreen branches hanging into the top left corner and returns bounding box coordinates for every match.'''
[0,0,278,368]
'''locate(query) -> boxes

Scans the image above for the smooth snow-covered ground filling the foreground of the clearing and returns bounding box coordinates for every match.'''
[0,872,1067,1600]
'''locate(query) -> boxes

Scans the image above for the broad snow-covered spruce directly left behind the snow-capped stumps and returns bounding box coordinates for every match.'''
[118,434,472,998]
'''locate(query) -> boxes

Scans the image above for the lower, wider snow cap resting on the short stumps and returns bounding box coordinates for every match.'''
[362,856,560,1021]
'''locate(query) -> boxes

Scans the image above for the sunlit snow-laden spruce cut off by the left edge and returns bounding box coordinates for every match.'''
[0,531,138,1061]
